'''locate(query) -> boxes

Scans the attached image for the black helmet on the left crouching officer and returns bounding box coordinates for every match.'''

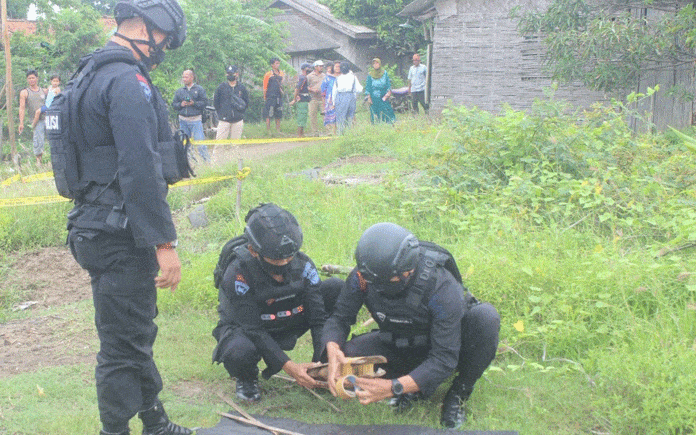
[244,203,302,260]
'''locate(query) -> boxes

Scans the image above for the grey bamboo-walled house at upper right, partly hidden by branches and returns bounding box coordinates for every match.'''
[398,0,694,129]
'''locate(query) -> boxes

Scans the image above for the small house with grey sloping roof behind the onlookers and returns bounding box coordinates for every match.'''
[269,0,377,72]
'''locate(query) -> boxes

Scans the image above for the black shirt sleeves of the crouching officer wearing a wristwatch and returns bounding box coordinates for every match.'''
[322,267,464,396]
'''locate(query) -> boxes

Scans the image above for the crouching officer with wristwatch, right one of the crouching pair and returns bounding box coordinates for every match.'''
[322,223,500,427]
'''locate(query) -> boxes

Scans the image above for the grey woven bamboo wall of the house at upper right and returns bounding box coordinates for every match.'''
[431,0,604,112]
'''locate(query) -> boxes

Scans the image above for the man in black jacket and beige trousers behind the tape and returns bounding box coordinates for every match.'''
[213,65,249,140]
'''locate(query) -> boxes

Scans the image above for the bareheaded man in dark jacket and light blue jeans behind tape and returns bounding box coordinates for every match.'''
[172,69,210,162]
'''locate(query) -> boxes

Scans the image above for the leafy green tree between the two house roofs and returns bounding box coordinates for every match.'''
[320,0,426,56]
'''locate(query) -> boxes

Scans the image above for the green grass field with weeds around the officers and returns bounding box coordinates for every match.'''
[0,107,696,435]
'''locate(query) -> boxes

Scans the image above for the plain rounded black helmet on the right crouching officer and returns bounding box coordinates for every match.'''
[355,222,419,284]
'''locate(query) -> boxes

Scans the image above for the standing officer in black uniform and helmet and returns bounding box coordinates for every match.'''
[68,0,192,435]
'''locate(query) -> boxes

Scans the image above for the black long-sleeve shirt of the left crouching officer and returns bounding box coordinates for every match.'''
[213,252,327,377]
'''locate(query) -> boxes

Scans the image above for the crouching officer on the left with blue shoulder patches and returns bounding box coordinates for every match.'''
[213,203,343,401]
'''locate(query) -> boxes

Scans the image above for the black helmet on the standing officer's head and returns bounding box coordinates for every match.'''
[114,0,186,50]
